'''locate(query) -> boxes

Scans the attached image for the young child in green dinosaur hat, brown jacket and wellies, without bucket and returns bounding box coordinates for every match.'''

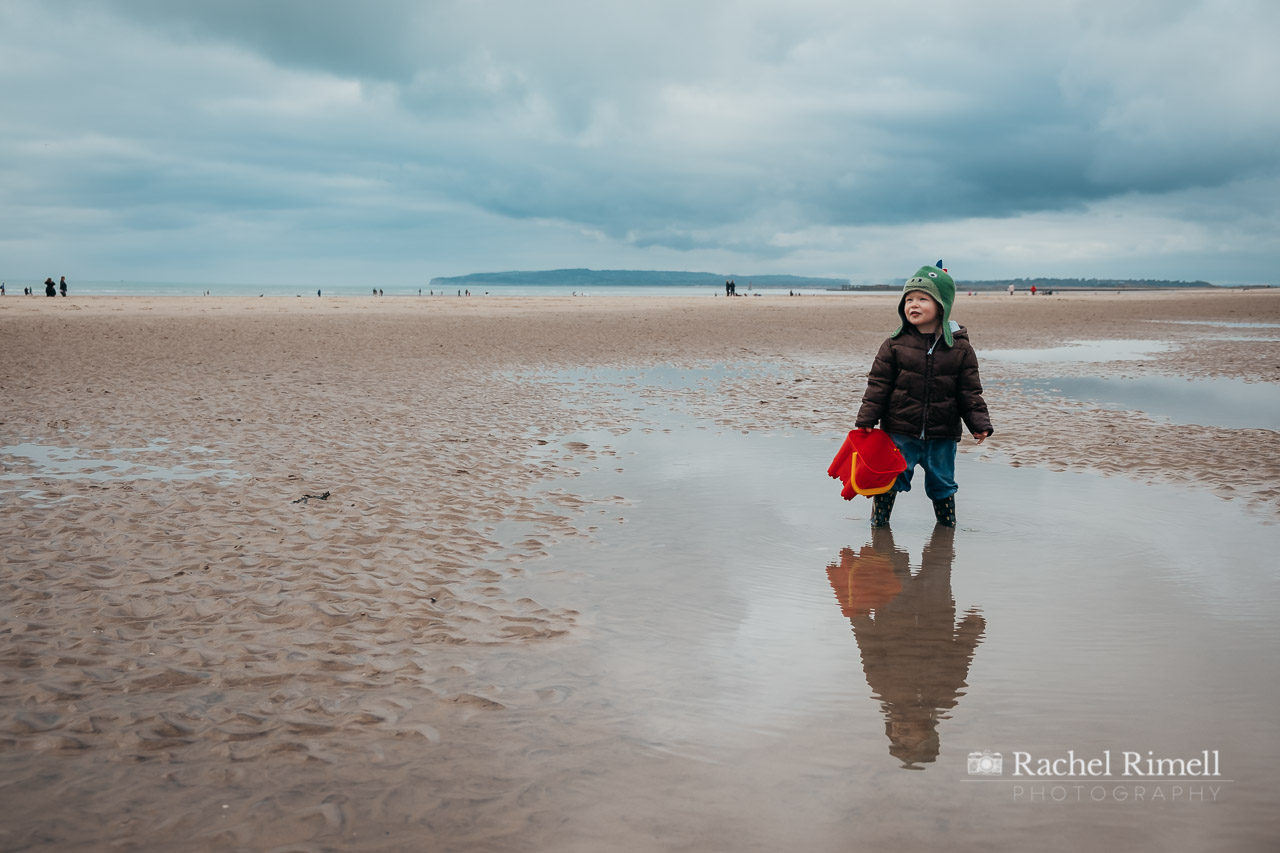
[854,261,992,528]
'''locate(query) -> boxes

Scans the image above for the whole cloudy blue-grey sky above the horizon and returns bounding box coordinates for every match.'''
[0,0,1280,284]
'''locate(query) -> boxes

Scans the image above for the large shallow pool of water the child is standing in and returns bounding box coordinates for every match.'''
[442,366,1280,850]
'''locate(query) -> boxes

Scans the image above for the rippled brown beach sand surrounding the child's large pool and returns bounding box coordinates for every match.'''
[0,289,1280,850]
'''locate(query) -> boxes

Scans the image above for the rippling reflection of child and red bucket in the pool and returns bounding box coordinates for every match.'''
[827,526,987,770]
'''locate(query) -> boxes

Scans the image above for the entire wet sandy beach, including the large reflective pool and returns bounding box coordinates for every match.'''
[0,291,1280,850]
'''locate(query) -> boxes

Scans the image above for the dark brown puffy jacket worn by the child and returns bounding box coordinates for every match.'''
[855,325,992,441]
